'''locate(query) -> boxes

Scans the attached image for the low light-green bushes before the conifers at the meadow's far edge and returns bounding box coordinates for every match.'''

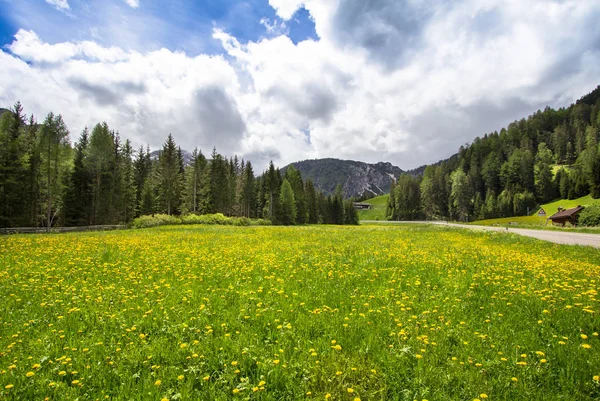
[133,213,271,228]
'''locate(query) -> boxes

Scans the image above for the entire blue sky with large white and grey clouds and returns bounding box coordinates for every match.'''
[0,0,600,171]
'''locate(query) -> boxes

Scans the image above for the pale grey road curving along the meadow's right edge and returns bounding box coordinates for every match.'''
[361,220,600,248]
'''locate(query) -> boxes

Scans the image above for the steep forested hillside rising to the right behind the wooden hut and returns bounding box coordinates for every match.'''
[387,86,600,220]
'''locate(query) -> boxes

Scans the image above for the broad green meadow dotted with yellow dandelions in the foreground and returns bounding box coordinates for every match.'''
[0,226,600,401]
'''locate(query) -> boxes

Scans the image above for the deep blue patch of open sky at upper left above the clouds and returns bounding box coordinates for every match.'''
[0,0,317,55]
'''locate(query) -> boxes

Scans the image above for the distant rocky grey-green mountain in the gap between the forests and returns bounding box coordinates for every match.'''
[281,159,402,197]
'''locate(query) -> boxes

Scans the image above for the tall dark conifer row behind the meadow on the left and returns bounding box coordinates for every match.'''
[0,102,358,228]
